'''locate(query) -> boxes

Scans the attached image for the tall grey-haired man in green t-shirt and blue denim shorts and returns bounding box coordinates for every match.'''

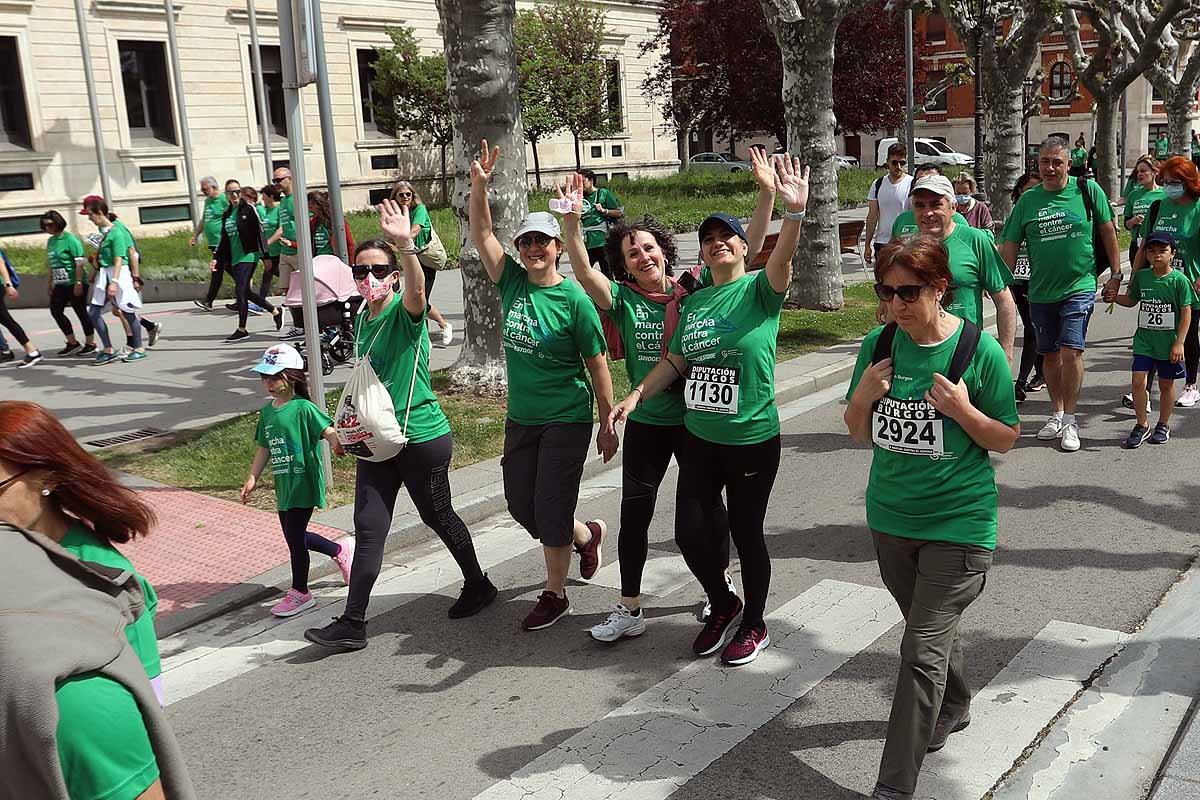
[1000,137,1121,452]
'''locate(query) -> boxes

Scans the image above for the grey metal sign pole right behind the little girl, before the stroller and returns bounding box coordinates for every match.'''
[273,0,332,481]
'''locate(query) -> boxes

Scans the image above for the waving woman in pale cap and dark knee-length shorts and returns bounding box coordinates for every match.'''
[469,140,617,631]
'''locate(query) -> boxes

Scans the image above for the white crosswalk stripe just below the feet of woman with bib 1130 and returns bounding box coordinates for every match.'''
[476,581,901,800]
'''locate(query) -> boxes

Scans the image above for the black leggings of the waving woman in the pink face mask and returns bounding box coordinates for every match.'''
[346,433,484,621]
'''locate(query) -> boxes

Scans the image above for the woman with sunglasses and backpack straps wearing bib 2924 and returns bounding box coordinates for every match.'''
[845,235,1020,800]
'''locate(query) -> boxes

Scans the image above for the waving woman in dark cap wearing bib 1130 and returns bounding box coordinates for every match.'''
[607,156,809,666]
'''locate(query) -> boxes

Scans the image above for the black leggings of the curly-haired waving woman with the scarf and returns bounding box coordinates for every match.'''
[617,420,730,597]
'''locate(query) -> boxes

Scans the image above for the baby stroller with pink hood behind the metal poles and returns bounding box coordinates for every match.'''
[283,255,362,375]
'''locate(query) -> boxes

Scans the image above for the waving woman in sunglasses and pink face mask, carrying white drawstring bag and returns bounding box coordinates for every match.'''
[304,200,496,650]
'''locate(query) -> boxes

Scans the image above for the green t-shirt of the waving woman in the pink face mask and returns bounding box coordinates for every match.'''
[355,294,450,444]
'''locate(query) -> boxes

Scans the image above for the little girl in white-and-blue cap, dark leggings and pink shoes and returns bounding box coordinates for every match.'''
[241,344,354,616]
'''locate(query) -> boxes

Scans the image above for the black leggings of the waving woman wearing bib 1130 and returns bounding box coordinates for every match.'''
[676,432,780,626]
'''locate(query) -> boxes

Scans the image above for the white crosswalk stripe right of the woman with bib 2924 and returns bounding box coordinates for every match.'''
[914,620,1127,800]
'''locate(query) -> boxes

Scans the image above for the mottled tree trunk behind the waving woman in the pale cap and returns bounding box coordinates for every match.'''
[437,0,527,396]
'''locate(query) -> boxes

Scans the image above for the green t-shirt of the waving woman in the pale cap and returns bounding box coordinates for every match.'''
[496,255,605,425]
